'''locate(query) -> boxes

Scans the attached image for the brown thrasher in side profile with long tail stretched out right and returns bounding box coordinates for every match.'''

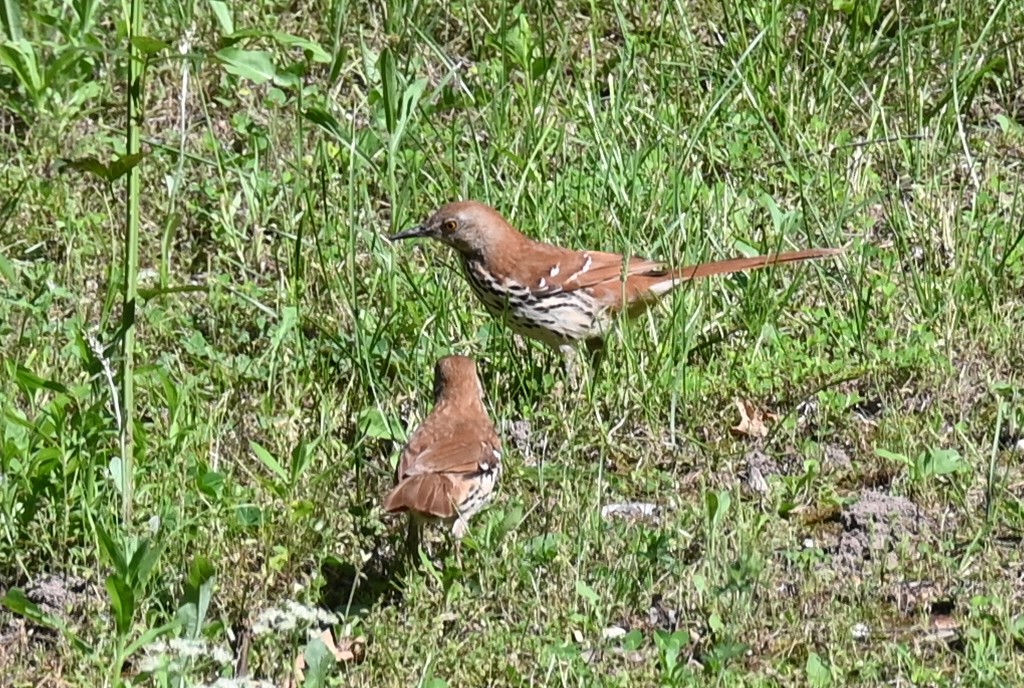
[389,201,842,360]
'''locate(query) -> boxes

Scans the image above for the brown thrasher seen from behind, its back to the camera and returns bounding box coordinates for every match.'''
[384,356,502,555]
